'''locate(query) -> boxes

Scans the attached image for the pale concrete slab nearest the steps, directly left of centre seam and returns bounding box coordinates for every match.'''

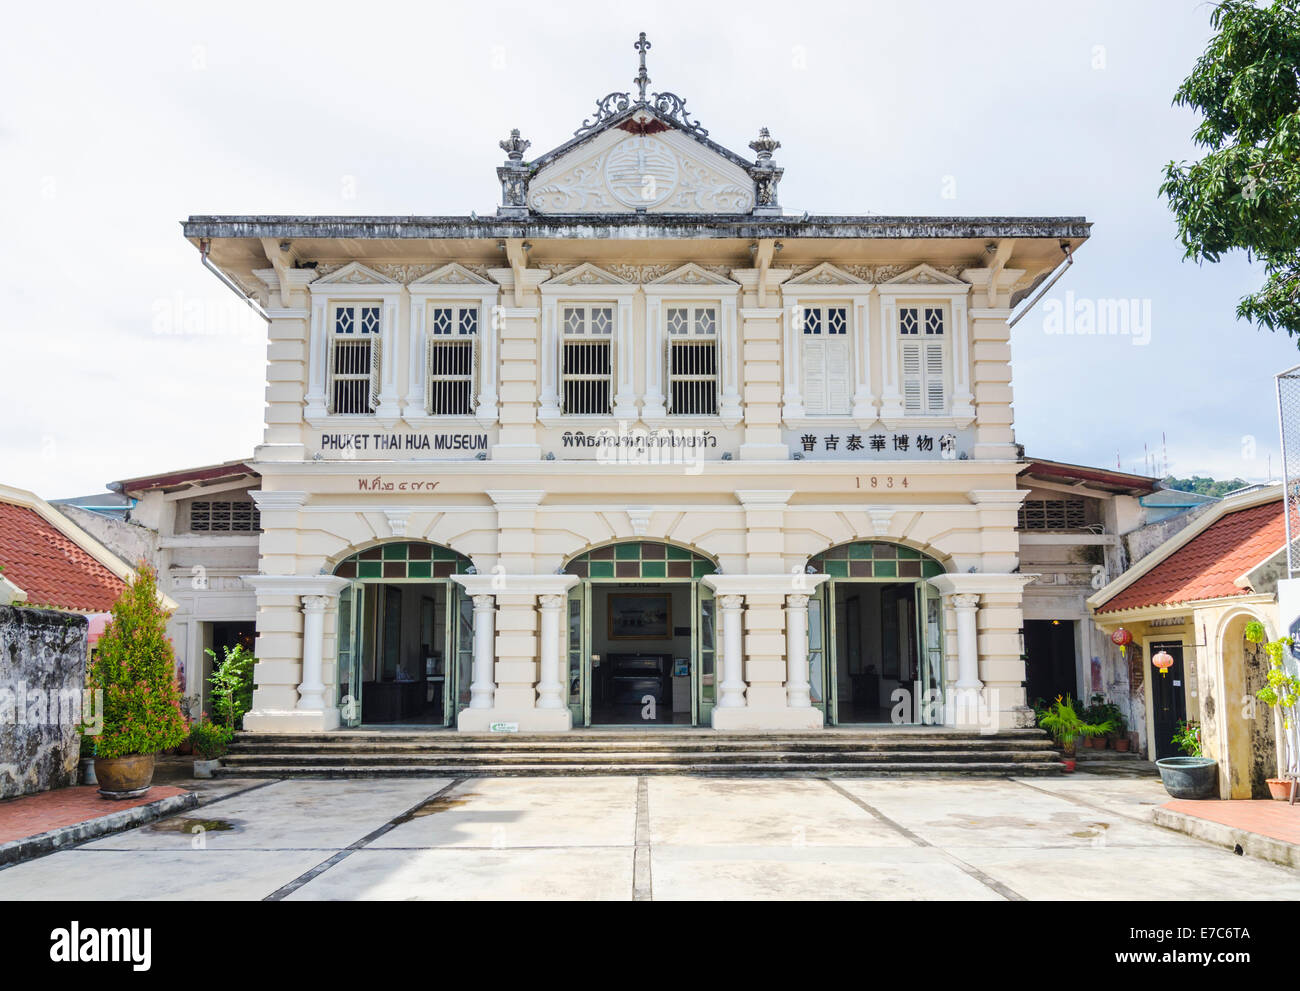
[371,778,637,849]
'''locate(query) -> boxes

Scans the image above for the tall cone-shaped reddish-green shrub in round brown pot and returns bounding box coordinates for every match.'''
[86,562,186,799]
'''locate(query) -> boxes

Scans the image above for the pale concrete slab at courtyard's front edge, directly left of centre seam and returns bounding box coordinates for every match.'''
[286,847,633,901]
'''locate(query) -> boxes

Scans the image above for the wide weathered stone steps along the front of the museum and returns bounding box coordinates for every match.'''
[217,727,1065,778]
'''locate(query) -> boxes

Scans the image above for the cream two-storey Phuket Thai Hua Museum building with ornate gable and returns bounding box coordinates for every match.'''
[185,36,1089,731]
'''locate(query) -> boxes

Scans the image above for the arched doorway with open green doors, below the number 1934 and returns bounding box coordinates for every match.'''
[809,541,944,726]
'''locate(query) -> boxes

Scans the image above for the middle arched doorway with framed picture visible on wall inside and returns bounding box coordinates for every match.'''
[564,541,718,726]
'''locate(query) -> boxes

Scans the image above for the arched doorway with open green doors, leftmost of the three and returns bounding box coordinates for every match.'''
[334,541,473,726]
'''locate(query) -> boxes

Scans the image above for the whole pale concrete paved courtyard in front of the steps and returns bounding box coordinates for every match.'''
[0,774,1300,900]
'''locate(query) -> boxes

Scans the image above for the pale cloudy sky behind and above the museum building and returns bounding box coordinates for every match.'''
[0,0,1300,498]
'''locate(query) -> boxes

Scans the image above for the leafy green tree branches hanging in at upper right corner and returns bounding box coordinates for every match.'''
[1160,0,1300,334]
